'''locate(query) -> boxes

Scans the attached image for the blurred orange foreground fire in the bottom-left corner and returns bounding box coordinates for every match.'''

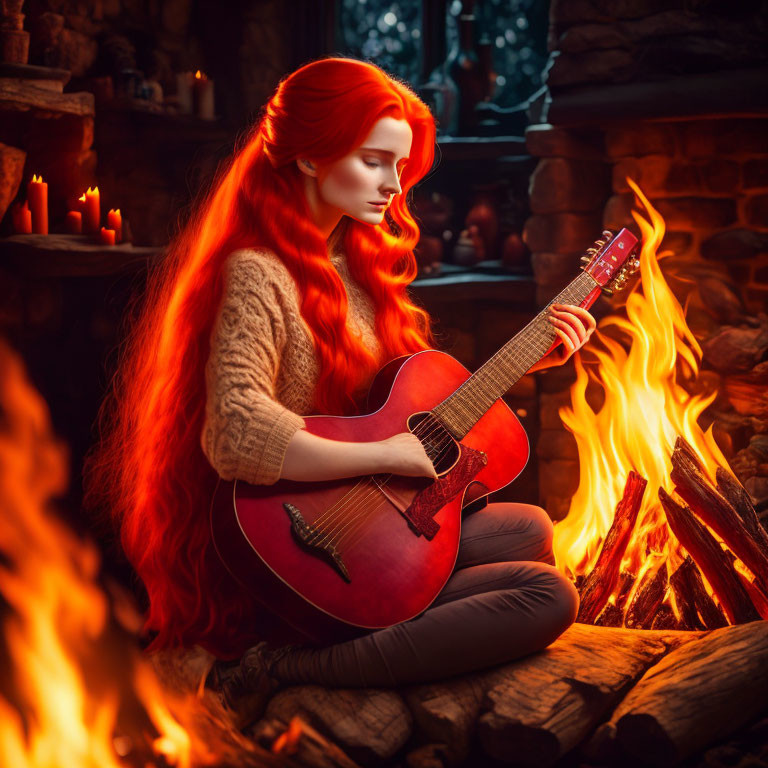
[0,341,258,768]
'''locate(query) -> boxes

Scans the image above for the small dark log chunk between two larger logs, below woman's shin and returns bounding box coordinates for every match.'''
[402,675,485,765]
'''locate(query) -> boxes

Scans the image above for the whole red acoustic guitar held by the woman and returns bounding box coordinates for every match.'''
[211,229,639,643]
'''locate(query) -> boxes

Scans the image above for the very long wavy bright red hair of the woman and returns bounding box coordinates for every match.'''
[86,58,435,655]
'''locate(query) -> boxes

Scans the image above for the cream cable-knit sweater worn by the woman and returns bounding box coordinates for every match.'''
[201,249,381,485]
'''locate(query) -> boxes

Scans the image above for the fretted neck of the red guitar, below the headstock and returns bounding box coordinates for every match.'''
[432,272,600,440]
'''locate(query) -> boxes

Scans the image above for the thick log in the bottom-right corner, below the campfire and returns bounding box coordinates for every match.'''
[602,621,768,766]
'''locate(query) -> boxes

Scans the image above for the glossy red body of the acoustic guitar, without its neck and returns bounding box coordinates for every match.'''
[211,350,529,643]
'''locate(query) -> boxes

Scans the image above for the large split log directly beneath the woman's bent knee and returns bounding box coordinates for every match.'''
[477,624,701,768]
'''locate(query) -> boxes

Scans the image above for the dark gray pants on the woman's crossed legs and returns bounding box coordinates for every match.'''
[273,502,579,687]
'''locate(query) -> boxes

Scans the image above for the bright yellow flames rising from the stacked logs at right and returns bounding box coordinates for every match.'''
[554,179,727,592]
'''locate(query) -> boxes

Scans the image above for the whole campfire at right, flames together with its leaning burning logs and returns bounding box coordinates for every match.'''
[554,179,768,629]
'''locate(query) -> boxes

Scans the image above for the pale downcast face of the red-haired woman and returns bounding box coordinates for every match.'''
[310,117,413,224]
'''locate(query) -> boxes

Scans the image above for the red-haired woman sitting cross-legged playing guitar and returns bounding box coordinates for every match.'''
[90,58,595,704]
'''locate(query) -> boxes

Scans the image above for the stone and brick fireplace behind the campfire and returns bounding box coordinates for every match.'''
[524,0,768,520]
